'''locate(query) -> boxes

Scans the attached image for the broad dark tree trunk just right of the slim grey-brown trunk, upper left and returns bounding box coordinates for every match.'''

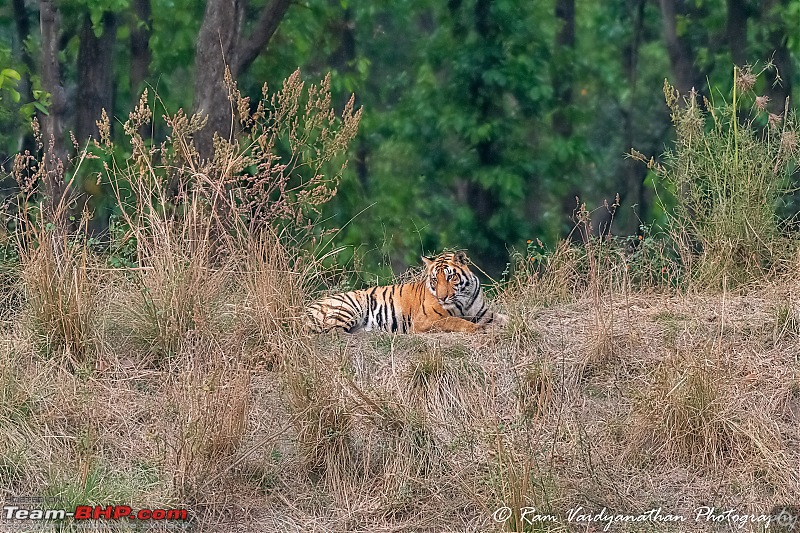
[75,12,117,143]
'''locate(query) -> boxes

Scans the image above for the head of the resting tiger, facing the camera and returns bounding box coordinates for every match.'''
[422,251,480,307]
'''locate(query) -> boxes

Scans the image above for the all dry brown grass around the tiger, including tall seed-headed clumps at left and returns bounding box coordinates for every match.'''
[0,68,800,532]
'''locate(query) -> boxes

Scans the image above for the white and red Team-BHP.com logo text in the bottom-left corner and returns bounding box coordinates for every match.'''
[3,505,189,521]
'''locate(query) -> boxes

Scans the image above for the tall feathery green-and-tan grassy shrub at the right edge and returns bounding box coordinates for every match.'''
[632,66,800,288]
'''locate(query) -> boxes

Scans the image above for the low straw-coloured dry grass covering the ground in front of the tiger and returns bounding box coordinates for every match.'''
[0,250,800,531]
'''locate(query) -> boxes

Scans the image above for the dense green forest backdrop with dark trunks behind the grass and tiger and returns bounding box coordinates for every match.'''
[0,0,800,279]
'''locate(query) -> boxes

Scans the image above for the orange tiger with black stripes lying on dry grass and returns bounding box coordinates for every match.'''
[306,251,508,333]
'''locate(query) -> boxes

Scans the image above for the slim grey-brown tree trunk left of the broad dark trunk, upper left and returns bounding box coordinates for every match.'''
[39,0,66,209]
